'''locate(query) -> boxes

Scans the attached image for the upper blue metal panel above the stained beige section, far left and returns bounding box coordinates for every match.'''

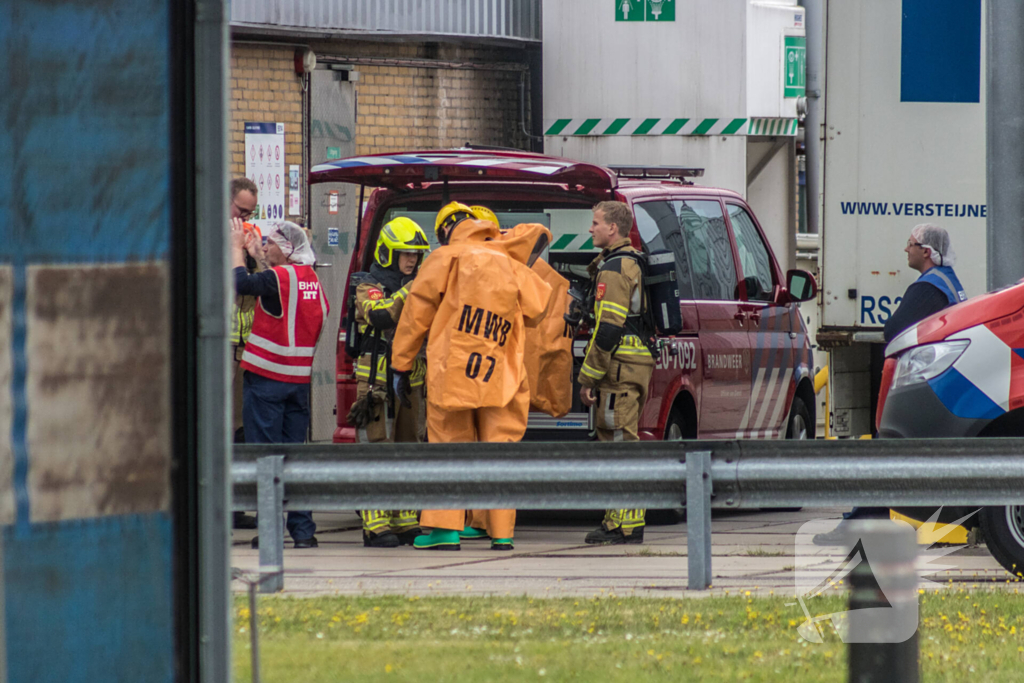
[0,0,170,263]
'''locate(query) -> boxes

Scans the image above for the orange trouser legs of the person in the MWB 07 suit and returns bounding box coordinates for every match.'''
[420,379,529,539]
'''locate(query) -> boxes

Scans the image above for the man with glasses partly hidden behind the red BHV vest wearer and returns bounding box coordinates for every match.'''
[228,176,267,528]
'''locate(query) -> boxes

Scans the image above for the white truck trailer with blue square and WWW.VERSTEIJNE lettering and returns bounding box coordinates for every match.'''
[807,0,987,437]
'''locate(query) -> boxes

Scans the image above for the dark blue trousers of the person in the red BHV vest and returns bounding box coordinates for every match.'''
[242,370,316,541]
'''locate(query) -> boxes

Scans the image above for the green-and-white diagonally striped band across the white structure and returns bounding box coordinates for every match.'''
[544,118,798,136]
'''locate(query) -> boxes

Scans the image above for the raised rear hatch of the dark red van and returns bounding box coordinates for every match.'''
[309,150,617,193]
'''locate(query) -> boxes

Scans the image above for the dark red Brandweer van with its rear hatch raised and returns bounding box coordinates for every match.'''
[310,148,816,442]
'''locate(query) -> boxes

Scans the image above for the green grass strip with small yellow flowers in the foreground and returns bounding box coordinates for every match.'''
[233,589,1024,683]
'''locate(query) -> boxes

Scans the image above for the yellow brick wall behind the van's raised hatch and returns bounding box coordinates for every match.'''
[229,41,529,215]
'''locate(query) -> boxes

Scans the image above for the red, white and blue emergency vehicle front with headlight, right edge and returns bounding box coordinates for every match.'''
[877,282,1024,575]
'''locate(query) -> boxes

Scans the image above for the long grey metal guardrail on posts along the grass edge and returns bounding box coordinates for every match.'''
[231,438,1024,591]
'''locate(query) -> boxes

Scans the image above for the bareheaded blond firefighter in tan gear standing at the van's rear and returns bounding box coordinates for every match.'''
[579,202,654,544]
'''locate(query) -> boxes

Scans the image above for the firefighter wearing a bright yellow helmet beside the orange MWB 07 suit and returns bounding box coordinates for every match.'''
[349,217,430,548]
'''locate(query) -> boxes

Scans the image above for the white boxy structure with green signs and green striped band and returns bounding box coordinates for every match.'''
[543,0,805,276]
